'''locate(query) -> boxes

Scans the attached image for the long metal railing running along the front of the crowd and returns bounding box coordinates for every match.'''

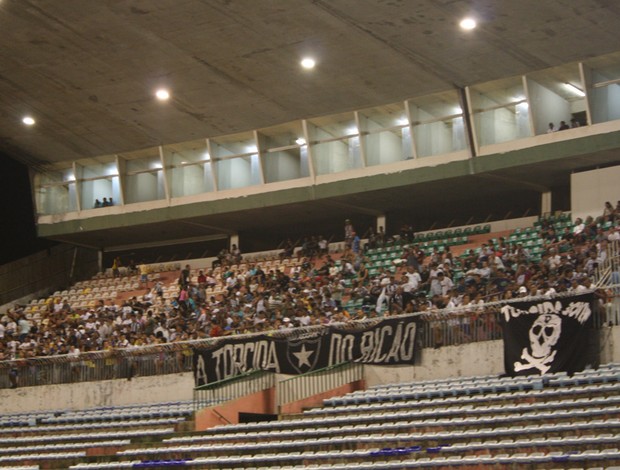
[0,290,620,393]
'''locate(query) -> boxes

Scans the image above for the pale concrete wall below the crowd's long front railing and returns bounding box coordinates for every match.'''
[0,326,620,414]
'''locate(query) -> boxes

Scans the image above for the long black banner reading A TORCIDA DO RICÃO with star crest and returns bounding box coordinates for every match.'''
[194,317,417,387]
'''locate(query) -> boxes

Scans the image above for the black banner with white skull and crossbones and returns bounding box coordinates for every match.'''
[501,294,594,375]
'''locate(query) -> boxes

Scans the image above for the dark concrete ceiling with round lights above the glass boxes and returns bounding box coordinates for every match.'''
[0,0,620,165]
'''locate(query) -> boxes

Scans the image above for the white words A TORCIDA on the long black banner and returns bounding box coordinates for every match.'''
[212,340,280,382]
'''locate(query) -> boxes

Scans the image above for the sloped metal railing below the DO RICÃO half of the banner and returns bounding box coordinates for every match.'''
[276,362,364,409]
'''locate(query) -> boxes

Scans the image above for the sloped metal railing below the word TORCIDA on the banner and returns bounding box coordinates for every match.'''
[194,370,276,410]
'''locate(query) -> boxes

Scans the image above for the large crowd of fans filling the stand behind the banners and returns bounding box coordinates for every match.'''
[0,205,620,360]
